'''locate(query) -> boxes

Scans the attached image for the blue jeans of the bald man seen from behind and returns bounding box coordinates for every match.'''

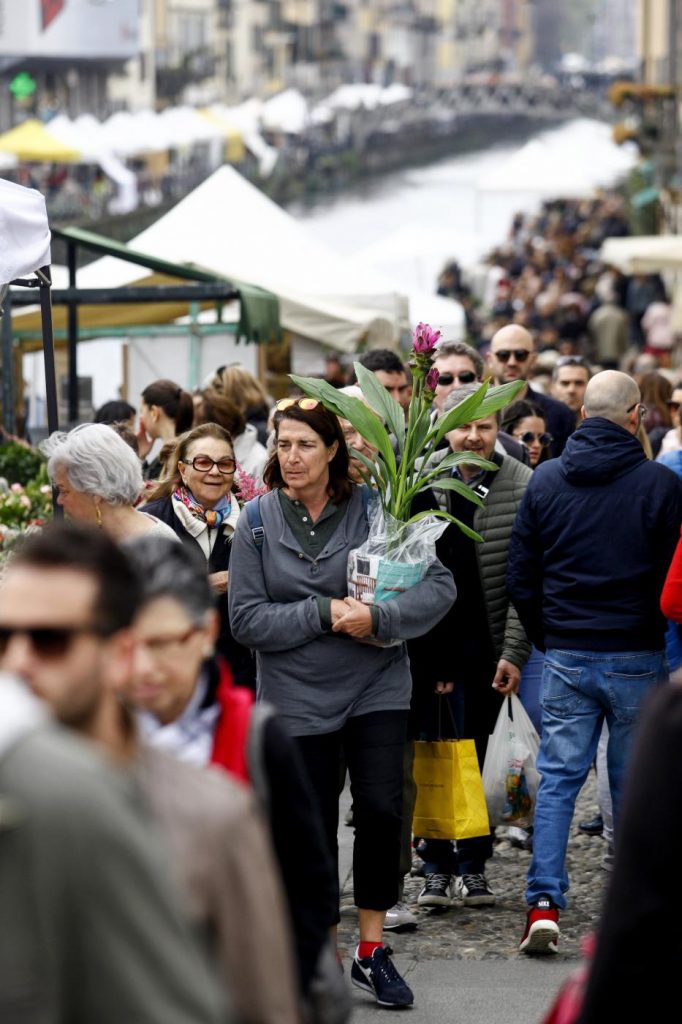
[525,649,664,909]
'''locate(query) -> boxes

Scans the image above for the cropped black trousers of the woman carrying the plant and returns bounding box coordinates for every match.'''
[296,711,408,910]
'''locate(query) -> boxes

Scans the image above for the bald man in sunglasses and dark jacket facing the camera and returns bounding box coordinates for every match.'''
[487,324,576,456]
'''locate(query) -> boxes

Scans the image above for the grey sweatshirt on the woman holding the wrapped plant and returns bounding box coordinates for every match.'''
[229,487,456,736]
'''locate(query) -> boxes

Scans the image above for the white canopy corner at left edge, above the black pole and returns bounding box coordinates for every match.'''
[0,179,50,286]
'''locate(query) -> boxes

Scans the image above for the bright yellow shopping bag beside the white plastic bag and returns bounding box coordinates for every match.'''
[412,739,491,839]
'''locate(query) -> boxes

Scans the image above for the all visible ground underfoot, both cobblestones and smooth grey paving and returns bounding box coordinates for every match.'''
[339,773,608,1024]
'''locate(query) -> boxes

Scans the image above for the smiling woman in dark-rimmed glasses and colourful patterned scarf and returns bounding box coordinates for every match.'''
[143,423,254,686]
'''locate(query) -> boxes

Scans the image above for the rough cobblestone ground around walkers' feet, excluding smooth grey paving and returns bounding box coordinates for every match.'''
[339,772,608,961]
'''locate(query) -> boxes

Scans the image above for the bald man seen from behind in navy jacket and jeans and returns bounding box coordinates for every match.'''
[507,370,682,953]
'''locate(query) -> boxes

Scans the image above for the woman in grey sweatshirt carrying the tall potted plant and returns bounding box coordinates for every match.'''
[229,398,455,1007]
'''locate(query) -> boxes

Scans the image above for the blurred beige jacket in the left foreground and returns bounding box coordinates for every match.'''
[136,744,300,1024]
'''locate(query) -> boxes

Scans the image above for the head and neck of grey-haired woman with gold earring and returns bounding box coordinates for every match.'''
[41,423,179,543]
